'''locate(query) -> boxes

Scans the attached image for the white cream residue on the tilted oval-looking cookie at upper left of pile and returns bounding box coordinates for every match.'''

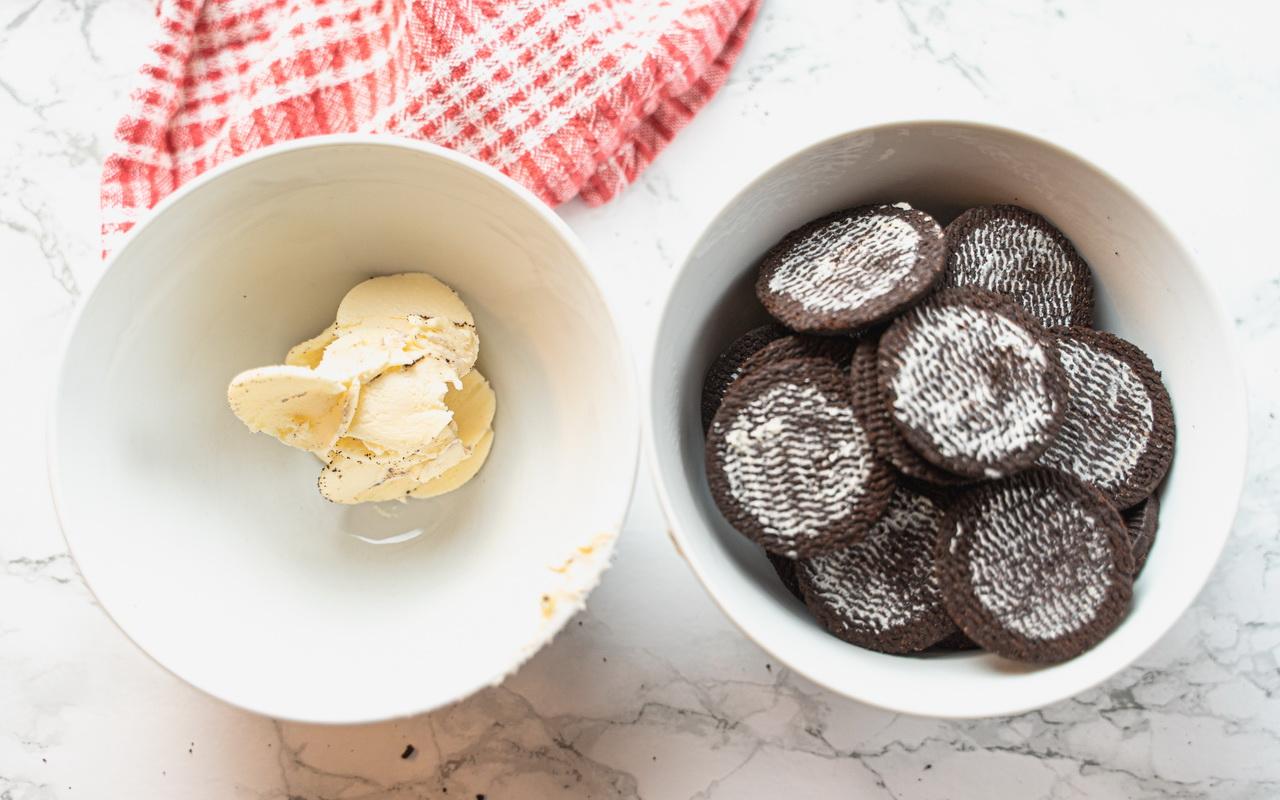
[768,212,922,314]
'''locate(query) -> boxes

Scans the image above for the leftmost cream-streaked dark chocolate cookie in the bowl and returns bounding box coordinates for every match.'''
[707,358,893,558]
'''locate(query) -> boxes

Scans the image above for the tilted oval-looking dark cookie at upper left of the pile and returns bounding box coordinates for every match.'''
[755,204,946,334]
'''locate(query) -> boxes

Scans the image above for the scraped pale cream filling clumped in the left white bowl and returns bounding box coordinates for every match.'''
[227,273,497,503]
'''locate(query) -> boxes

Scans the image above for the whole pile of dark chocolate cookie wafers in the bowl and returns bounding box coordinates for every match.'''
[703,204,1174,663]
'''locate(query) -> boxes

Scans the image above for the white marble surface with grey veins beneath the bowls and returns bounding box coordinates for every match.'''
[0,0,1280,800]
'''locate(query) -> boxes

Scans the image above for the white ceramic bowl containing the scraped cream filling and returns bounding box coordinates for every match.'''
[49,136,639,722]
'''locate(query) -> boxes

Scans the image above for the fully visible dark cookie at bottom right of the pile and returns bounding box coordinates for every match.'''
[934,468,1133,663]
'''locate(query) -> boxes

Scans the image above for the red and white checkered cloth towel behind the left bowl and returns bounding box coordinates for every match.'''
[102,0,759,251]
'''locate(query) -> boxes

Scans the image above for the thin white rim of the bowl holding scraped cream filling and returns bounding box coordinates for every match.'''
[45,133,643,724]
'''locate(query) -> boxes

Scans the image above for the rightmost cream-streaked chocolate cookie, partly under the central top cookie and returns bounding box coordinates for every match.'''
[1039,328,1174,508]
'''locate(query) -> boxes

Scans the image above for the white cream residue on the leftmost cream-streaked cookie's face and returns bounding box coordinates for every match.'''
[723,384,872,539]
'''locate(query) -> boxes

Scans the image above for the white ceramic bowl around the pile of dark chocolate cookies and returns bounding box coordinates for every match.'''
[648,122,1245,717]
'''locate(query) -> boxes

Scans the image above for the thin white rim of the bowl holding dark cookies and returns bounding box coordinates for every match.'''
[644,116,1248,719]
